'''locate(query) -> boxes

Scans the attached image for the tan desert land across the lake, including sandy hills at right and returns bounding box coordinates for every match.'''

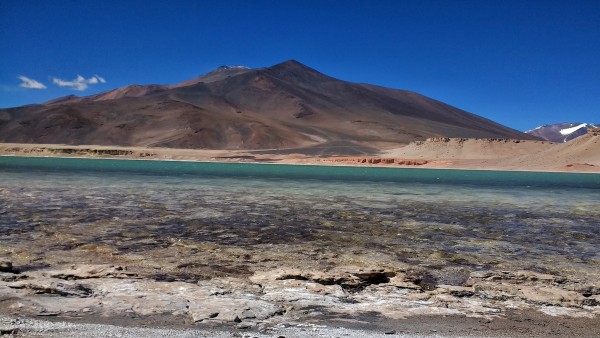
[0,129,600,173]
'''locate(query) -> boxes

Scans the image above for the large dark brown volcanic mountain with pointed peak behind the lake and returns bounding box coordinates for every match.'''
[0,61,534,154]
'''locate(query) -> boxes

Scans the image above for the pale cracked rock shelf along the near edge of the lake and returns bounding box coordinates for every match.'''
[0,261,600,336]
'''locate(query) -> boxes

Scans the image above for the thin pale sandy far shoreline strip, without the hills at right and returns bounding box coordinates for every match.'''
[0,143,600,174]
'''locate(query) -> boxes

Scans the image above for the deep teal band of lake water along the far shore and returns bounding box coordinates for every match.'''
[0,157,600,189]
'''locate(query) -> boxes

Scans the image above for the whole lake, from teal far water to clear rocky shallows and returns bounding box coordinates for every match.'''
[0,157,600,278]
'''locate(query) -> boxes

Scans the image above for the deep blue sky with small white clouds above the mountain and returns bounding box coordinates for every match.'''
[0,0,600,130]
